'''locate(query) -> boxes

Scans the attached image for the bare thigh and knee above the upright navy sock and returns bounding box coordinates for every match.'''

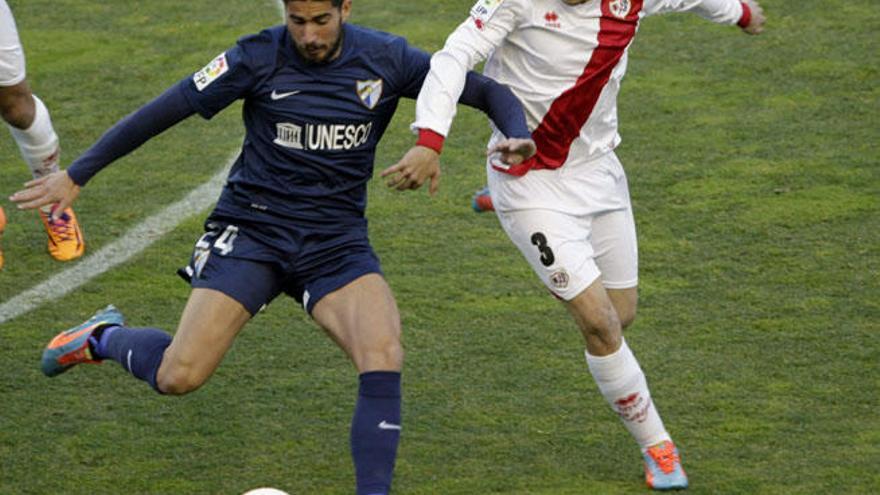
[312,273,403,373]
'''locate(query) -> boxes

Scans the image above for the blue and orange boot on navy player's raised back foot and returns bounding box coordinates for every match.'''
[40,304,125,376]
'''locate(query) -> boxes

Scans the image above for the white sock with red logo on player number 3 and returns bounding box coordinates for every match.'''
[584,339,670,451]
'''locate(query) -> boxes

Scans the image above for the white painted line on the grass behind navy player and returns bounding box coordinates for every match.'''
[0,154,238,324]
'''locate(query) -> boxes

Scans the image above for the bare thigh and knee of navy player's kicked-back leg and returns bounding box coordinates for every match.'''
[156,289,251,394]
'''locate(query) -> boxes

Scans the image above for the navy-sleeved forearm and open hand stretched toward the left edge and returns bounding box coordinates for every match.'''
[9,84,195,216]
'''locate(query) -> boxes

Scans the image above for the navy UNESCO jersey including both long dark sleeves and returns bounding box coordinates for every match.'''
[67,25,530,225]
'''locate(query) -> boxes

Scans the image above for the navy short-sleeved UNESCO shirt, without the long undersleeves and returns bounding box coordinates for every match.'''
[181,24,430,220]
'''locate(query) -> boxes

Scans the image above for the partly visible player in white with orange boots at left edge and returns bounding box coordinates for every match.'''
[0,0,85,268]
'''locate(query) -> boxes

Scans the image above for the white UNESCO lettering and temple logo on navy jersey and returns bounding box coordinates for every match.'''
[272,122,373,151]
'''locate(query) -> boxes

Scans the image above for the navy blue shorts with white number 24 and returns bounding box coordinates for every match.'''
[178,219,382,315]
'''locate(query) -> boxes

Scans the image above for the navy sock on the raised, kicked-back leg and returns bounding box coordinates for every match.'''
[91,326,171,393]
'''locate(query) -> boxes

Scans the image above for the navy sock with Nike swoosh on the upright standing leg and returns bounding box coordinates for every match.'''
[351,371,400,495]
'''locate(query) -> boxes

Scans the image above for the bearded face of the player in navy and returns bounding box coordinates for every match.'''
[286,0,351,63]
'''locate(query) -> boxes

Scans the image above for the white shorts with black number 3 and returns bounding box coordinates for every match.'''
[489,153,638,301]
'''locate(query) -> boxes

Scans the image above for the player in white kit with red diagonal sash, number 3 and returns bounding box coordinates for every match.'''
[386,0,764,490]
